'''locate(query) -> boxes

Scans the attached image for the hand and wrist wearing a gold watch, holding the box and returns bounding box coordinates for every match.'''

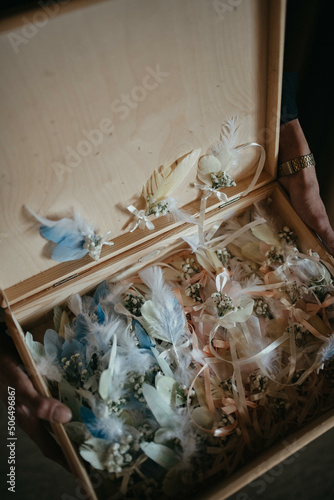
[278,119,334,254]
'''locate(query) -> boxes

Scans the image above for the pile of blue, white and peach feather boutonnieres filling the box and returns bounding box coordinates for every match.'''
[26,202,334,499]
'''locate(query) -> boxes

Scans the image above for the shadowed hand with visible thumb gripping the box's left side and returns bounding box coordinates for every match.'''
[0,335,72,468]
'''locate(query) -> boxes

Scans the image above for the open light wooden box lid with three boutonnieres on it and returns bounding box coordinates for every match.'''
[0,0,284,298]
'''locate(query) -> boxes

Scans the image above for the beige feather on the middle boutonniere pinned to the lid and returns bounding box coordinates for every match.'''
[142,149,201,202]
